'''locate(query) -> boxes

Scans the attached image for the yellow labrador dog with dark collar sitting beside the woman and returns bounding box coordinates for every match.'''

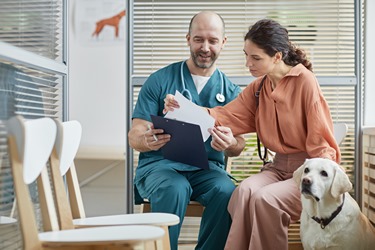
[293,158,375,250]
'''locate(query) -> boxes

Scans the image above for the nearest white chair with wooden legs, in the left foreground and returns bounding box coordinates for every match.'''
[7,116,164,250]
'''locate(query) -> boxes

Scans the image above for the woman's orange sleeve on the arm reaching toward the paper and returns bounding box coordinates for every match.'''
[208,83,256,135]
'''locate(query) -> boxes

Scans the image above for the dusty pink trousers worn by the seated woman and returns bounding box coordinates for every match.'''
[225,153,309,250]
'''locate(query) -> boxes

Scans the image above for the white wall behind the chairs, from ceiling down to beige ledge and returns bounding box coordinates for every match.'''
[69,0,126,159]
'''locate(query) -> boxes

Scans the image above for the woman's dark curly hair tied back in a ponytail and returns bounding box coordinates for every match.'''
[245,19,312,71]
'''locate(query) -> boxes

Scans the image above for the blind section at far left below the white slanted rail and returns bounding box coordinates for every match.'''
[0,60,63,120]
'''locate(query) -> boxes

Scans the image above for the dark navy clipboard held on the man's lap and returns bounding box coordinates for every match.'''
[151,115,209,169]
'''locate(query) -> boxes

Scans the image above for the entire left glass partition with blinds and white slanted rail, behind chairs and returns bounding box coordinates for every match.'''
[0,0,67,250]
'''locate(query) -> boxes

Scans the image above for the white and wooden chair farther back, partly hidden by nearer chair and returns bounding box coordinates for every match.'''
[50,120,180,250]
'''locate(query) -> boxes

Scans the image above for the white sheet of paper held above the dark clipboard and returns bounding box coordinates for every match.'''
[165,91,215,141]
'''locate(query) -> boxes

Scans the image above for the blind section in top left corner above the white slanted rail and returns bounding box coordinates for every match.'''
[0,0,63,62]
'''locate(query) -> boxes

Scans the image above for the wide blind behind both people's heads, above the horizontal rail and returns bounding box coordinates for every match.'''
[133,0,355,76]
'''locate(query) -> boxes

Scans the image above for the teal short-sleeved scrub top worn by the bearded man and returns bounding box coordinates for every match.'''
[132,62,241,182]
